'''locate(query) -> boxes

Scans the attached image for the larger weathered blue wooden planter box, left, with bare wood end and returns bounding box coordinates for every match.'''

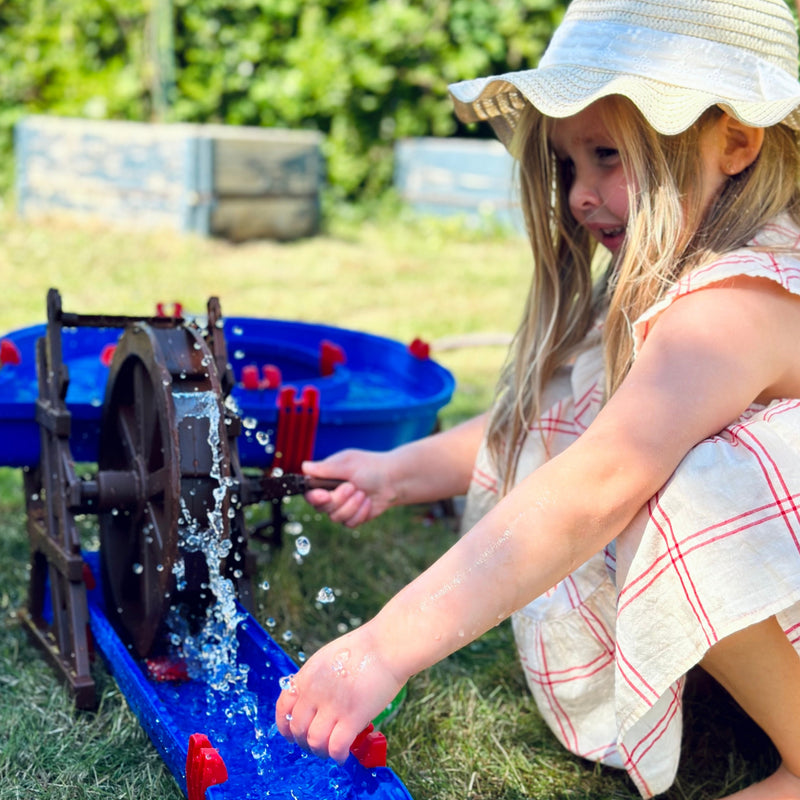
[14,116,323,241]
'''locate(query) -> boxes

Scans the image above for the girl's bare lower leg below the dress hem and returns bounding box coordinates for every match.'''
[700,617,800,800]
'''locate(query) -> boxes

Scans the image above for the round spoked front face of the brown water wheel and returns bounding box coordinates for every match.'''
[98,326,180,656]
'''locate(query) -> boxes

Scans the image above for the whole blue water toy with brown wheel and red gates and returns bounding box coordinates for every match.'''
[0,289,453,800]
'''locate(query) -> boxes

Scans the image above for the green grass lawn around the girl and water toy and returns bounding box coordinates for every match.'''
[0,212,772,800]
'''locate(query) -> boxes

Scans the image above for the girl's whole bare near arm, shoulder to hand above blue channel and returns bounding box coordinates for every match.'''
[277,281,800,761]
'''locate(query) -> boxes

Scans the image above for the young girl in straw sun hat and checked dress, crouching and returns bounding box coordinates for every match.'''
[277,0,800,800]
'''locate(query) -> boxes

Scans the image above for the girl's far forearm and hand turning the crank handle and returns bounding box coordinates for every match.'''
[303,414,487,527]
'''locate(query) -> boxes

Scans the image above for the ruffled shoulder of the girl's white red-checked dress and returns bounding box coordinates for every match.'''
[633,215,800,351]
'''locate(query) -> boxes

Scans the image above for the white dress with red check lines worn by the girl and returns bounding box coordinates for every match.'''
[462,218,800,797]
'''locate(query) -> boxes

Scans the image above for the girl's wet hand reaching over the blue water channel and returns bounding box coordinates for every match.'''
[275,623,405,764]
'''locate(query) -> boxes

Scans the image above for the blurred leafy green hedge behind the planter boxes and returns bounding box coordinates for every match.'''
[0,0,565,199]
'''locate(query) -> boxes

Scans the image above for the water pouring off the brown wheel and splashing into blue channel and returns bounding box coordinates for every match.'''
[146,392,396,800]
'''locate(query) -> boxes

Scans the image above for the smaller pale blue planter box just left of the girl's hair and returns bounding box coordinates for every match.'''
[394,137,524,232]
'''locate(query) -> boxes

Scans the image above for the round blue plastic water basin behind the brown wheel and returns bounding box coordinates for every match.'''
[0,317,455,468]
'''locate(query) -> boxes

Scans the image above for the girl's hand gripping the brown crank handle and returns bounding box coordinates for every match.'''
[303,450,397,528]
